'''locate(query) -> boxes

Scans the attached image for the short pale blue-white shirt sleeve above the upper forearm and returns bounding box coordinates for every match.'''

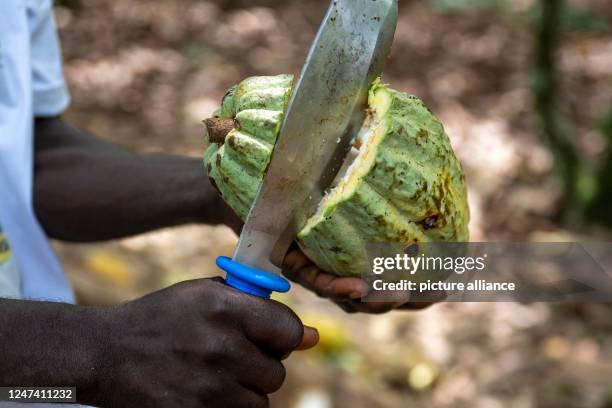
[26,0,70,116]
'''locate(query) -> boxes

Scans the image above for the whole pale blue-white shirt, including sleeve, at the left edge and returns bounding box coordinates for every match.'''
[0,0,74,300]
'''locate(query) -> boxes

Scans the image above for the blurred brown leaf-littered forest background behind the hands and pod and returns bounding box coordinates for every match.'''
[55,0,612,408]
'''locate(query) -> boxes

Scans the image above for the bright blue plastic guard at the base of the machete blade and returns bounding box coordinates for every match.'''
[216,256,291,299]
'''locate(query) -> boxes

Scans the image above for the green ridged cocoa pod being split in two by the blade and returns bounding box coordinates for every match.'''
[204,75,469,276]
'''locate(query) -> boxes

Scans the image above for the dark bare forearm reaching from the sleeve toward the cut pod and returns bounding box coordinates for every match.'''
[34,118,240,242]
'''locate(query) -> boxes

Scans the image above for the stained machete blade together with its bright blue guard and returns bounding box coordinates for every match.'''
[216,0,397,298]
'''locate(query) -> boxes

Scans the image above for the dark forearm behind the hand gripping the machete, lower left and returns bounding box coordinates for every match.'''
[0,299,106,392]
